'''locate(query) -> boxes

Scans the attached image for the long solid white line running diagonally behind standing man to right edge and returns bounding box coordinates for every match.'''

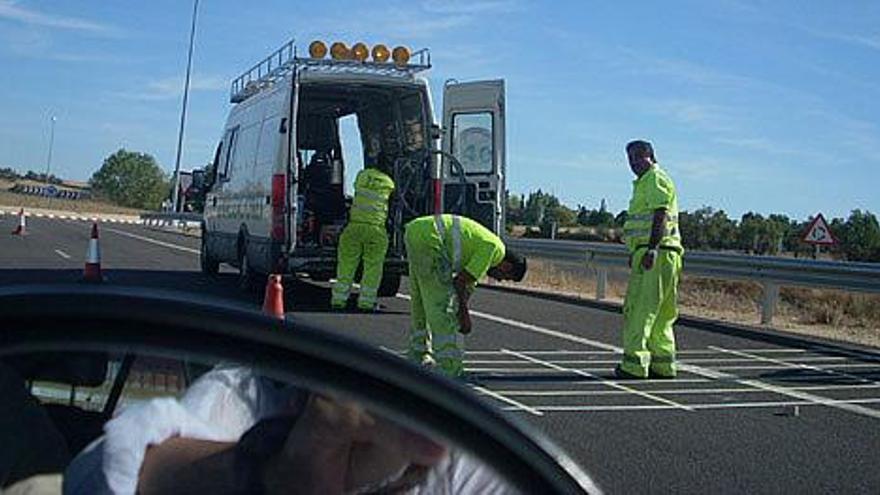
[397,294,880,419]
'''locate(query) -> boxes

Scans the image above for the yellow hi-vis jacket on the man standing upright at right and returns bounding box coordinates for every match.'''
[623,163,682,253]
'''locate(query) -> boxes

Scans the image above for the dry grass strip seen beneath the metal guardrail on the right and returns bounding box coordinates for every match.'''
[496,259,880,347]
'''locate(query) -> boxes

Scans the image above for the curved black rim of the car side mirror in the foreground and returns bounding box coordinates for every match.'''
[0,285,599,494]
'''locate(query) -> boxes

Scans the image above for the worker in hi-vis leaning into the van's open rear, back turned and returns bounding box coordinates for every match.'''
[330,154,394,311]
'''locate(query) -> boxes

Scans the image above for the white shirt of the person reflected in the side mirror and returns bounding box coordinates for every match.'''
[64,365,516,495]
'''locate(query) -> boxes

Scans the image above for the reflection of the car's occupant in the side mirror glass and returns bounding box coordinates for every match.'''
[0,352,519,494]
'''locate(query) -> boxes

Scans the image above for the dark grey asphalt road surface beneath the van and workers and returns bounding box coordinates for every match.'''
[0,215,880,493]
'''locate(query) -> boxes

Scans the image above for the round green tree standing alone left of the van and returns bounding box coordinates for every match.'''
[89,149,169,209]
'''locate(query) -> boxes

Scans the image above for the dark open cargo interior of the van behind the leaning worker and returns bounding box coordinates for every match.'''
[296,83,430,254]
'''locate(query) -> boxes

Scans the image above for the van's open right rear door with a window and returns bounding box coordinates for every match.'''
[442,79,506,235]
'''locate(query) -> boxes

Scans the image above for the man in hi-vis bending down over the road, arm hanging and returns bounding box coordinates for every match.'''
[404,214,526,377]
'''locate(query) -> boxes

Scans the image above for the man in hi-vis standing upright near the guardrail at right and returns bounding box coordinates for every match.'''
[615,141,684,378]
